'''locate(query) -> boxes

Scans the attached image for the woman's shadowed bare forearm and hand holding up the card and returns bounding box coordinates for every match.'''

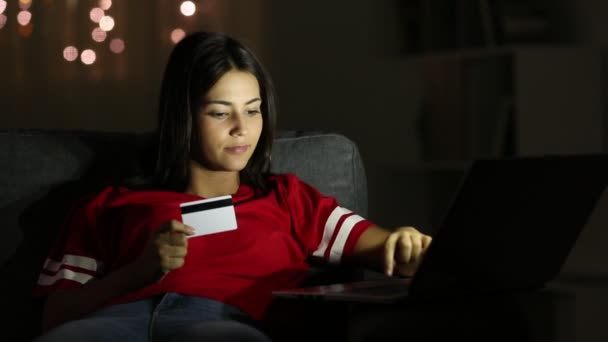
[42,220,194,331]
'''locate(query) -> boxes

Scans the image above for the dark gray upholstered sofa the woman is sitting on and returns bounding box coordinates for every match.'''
[0,129,367,341]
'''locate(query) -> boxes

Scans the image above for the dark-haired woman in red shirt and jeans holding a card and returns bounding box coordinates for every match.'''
[36,32,431,341]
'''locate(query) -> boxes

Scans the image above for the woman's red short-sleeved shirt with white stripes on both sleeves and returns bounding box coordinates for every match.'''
[34,174,372,319]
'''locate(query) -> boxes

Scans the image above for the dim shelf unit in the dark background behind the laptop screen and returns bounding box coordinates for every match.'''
[408,45,605,231]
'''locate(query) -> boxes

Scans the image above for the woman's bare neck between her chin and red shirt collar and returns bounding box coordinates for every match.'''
[186,162,240,198]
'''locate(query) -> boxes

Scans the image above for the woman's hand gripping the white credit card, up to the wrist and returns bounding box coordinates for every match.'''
[136,220,194,281]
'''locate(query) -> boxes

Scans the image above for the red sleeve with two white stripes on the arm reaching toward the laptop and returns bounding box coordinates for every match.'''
[286,175,373,264]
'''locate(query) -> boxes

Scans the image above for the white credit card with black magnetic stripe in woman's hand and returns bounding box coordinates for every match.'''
[180,195,237,237]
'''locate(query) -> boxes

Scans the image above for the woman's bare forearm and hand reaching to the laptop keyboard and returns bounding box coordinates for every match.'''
[351,226,432,276]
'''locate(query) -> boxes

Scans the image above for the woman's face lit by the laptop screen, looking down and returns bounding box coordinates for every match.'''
[193,70,263,172]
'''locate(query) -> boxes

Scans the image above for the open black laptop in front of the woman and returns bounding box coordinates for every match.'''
[273,154,608,303]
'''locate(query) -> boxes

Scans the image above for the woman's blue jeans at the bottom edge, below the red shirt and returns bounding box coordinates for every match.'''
[34,293,270,342]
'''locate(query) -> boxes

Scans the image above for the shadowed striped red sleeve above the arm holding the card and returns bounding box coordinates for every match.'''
[33,188,112,296]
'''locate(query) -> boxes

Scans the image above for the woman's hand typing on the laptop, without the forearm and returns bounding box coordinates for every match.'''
[384,227,432,277]
